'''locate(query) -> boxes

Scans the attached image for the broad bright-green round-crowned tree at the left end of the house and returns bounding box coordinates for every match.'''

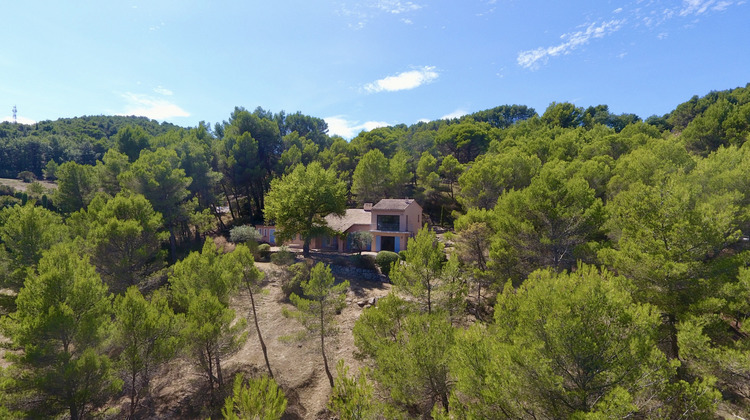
[265,162,346,256]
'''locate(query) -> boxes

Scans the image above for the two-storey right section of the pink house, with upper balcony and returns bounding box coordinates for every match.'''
[370,198,422,252]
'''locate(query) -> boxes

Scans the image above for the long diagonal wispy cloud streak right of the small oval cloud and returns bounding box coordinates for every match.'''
[516,19,625,70]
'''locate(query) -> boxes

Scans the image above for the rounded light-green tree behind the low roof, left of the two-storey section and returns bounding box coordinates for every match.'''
[352,149,390,204]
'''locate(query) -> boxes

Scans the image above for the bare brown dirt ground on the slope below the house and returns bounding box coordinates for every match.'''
[152,263,391,419]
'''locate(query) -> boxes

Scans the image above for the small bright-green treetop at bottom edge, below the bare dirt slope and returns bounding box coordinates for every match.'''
[221,373,287,420]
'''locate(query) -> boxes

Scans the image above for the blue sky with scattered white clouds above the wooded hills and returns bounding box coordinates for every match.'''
[0,0,750,138]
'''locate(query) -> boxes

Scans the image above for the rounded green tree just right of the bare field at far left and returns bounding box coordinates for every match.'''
[55,162,98,213]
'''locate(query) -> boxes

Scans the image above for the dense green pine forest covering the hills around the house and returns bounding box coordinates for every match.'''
[0,84,750,419]
